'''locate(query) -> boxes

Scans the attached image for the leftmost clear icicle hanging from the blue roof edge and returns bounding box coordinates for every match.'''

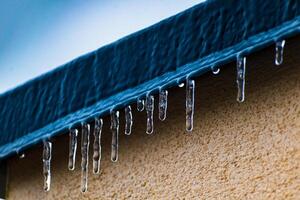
[43,140,52,192]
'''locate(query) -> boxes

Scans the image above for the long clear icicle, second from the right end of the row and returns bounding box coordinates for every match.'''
[236,57,246,102]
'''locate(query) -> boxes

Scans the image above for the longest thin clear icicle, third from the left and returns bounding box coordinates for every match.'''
[81,122,90,192]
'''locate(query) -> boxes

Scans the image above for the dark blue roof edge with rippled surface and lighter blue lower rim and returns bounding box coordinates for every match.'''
[0,0,300,158]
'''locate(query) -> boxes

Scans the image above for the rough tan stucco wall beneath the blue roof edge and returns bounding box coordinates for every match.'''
[8,37,300,200]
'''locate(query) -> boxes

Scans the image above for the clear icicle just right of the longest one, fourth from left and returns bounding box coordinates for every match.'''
[93,118,103,174]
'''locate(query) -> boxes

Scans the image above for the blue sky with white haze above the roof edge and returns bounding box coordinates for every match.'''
[0,0,203,93]
